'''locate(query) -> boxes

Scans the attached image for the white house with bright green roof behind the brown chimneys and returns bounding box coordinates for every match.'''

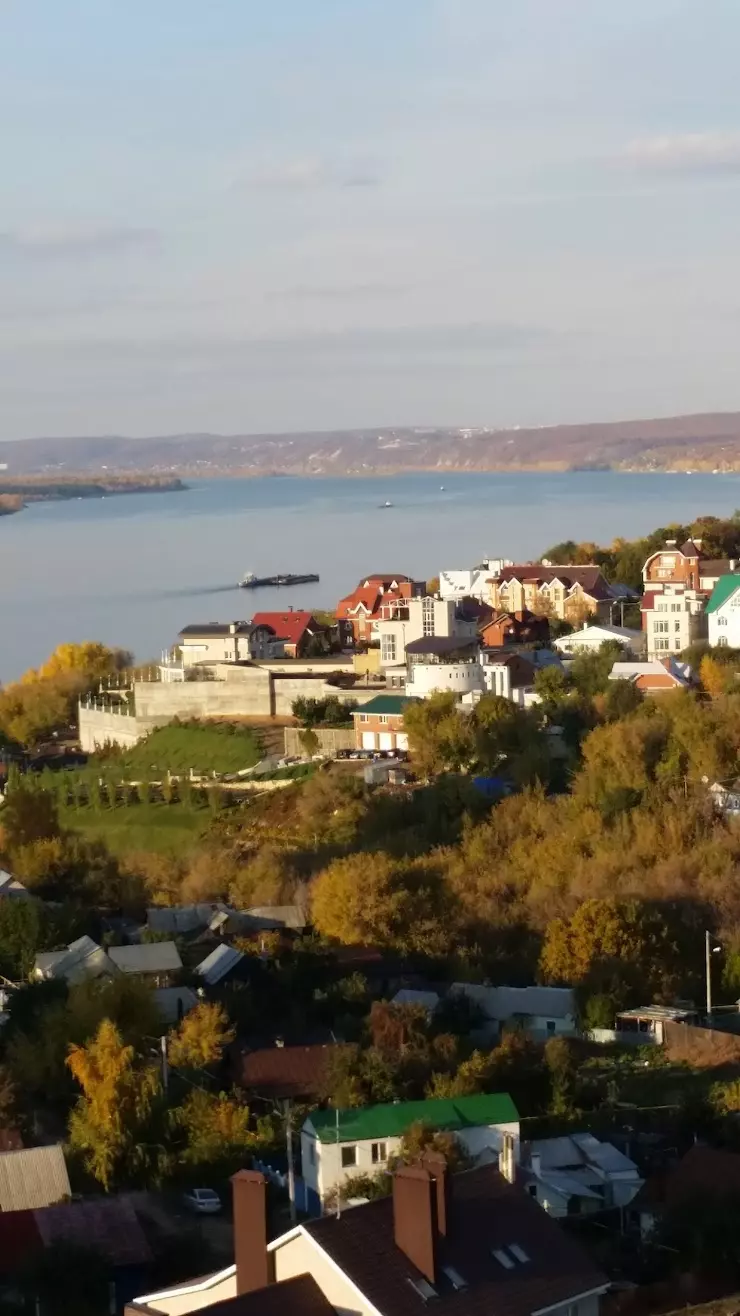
[300,1092,519,1202]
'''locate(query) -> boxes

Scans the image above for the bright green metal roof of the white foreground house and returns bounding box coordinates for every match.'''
[308,1092,519,1142]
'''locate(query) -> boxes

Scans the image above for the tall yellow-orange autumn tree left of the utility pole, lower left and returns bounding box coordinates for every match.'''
[67,1019,161,1192]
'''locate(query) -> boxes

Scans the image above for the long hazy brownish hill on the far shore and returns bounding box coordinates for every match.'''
[0,412,740,476]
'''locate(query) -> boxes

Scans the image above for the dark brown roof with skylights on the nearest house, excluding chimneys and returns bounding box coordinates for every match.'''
[302,1166,607,1316]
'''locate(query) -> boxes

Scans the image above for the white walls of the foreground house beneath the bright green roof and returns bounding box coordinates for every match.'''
[300,1117,519,1202]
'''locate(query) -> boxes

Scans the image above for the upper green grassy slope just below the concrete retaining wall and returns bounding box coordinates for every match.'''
[90,722,262,780]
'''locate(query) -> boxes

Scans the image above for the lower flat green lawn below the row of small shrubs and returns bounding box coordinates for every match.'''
[61,804,211,858]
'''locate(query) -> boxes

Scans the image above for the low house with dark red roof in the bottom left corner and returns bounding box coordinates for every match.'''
[0,1196,151,1311]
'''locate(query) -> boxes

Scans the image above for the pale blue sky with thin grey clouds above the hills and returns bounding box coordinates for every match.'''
[0,0,740,440]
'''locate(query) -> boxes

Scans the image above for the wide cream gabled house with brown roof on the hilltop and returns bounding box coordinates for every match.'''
[489,562,624,622]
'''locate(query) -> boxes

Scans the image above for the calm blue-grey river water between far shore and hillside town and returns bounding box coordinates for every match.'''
[0,471,740,682]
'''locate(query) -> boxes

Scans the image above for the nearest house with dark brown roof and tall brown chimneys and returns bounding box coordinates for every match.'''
[132,1154,608,1316]
